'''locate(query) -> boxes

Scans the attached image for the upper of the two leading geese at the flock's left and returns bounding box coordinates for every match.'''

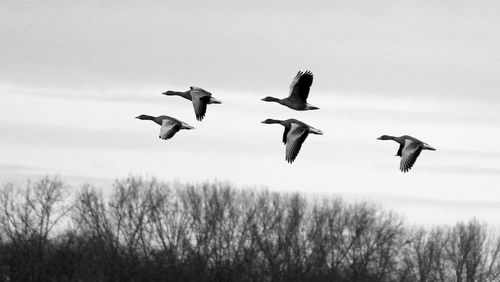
[162,86,222,121]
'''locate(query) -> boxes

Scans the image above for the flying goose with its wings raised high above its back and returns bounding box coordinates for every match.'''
[262,70,319,111]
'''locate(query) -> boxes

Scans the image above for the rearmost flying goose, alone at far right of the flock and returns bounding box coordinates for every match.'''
[377,135,436,173]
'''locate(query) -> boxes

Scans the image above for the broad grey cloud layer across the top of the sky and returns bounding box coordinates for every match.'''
[0,1,500,100]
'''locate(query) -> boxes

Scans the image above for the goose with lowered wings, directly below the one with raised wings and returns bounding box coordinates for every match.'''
[262,119,323,163]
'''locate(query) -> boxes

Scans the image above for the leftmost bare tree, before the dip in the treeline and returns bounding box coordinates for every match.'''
[0,177,71,281]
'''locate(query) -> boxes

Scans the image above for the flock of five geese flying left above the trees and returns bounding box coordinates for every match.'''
[136,71,436,172]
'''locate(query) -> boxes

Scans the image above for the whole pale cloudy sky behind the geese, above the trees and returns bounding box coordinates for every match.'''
[0,0,500,225]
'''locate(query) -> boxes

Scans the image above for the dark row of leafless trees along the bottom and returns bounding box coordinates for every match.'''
[0,177,500,282]
